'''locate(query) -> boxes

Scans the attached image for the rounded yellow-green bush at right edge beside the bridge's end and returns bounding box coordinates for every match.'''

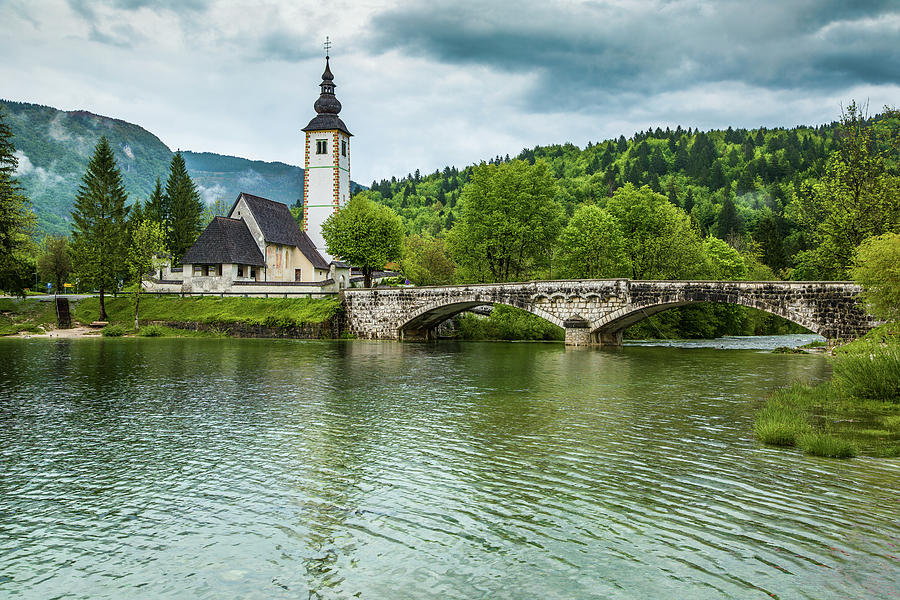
[852,233,900,320]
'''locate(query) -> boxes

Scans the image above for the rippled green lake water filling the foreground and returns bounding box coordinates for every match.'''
[0,338,900,599]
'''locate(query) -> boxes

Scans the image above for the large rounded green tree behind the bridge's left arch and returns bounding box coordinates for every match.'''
[448,160,564,282]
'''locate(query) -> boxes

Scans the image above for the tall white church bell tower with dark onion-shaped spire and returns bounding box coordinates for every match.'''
[303,38,352,260]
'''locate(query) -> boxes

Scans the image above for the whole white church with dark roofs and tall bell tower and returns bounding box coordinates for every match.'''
[144,56,352,295]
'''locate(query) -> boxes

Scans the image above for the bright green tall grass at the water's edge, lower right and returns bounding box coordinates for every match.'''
[754,323,900,458]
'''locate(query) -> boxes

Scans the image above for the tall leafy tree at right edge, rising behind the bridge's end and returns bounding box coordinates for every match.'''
[796,102,900,279]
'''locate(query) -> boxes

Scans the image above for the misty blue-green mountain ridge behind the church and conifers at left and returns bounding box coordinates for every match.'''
[0,99,357,234]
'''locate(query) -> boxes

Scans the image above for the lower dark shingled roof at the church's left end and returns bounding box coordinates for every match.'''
[181,217,266,267]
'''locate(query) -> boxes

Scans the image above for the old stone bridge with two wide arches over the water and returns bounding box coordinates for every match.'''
[342,279,876,346]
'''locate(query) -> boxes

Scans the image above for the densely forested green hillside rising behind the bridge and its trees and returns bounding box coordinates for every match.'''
[362,116,898,278]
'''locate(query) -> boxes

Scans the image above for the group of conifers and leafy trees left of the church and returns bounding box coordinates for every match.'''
[0,114,204,320]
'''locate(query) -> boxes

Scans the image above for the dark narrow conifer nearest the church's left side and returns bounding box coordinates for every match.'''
[166,152,203,264]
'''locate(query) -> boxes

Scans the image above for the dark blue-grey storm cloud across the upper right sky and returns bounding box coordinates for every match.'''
[369,0,900,110]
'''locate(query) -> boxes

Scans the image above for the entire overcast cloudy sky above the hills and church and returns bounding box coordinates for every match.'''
[0,0,900,184]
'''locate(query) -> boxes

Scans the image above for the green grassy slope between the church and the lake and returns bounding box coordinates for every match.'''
[73,296,341,336]
